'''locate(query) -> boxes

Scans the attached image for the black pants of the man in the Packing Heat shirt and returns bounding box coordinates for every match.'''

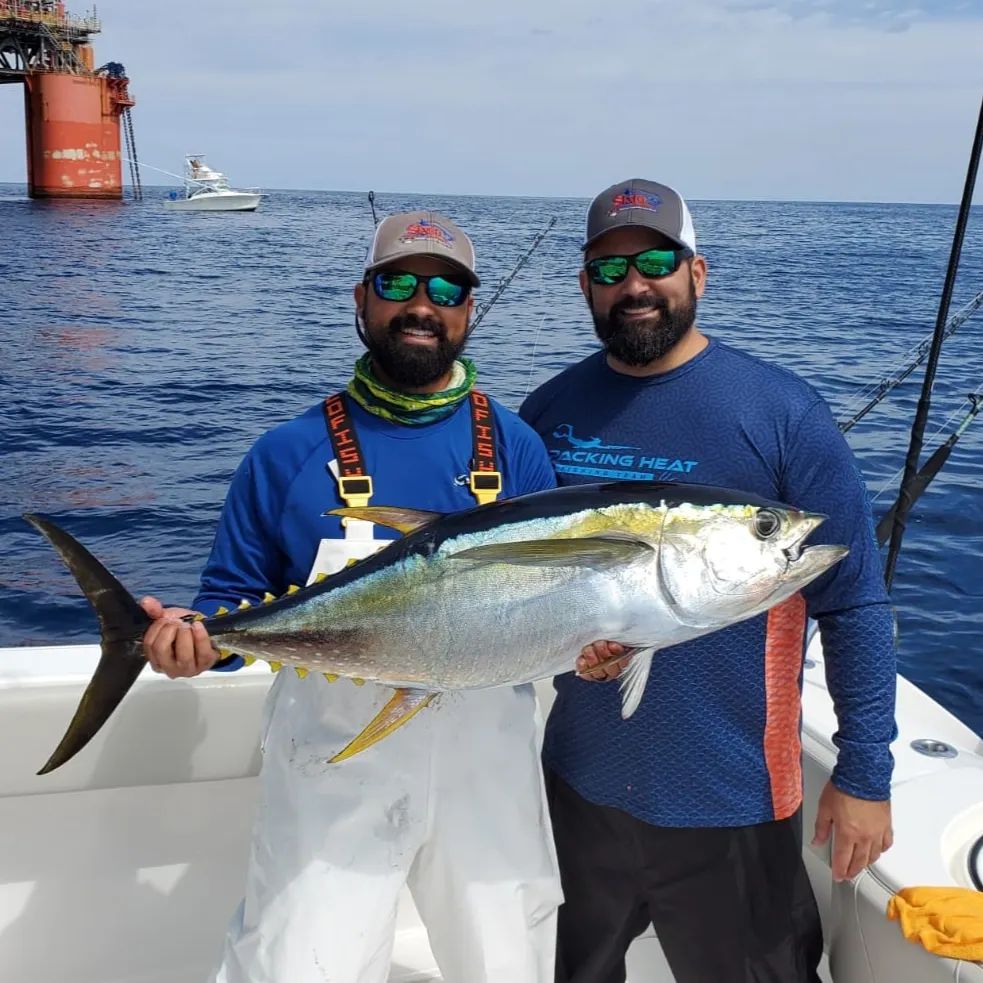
[546,771,823,983]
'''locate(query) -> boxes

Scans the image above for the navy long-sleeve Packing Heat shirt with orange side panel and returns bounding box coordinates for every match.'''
[520,339,896,826]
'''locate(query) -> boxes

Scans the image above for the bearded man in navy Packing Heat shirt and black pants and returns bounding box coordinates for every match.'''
[520,179,896,983]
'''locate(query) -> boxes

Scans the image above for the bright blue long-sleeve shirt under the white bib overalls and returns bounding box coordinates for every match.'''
[192,400,556,669]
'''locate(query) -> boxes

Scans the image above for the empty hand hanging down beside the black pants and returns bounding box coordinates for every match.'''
[812,782,894,881]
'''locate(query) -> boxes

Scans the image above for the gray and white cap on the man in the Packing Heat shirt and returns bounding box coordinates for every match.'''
[581,178,696,254]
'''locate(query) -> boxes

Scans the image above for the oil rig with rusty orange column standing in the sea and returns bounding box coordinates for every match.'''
[0,0,141,198]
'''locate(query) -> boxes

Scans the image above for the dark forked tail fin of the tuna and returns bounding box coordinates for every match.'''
[24,514,152,775]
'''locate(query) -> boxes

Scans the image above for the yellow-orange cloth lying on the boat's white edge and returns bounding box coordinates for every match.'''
[887,887,983,962]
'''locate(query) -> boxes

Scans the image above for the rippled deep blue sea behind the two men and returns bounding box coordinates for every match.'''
[0,185,983,733]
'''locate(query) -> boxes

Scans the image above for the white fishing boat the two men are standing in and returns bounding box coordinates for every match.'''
[0,639,983,983]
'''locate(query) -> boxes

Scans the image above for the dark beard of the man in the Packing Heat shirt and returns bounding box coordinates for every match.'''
[591,282,696,367]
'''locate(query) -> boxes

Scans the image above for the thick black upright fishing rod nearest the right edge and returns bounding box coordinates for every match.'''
[884,99,983,590]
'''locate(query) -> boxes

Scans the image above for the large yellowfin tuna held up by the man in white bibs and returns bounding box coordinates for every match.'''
[25,482,847,774]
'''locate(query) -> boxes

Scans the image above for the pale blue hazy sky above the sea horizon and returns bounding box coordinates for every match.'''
[0,0,983,202]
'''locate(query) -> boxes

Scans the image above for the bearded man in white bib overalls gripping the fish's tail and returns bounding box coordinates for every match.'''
[143,212,560,983]
